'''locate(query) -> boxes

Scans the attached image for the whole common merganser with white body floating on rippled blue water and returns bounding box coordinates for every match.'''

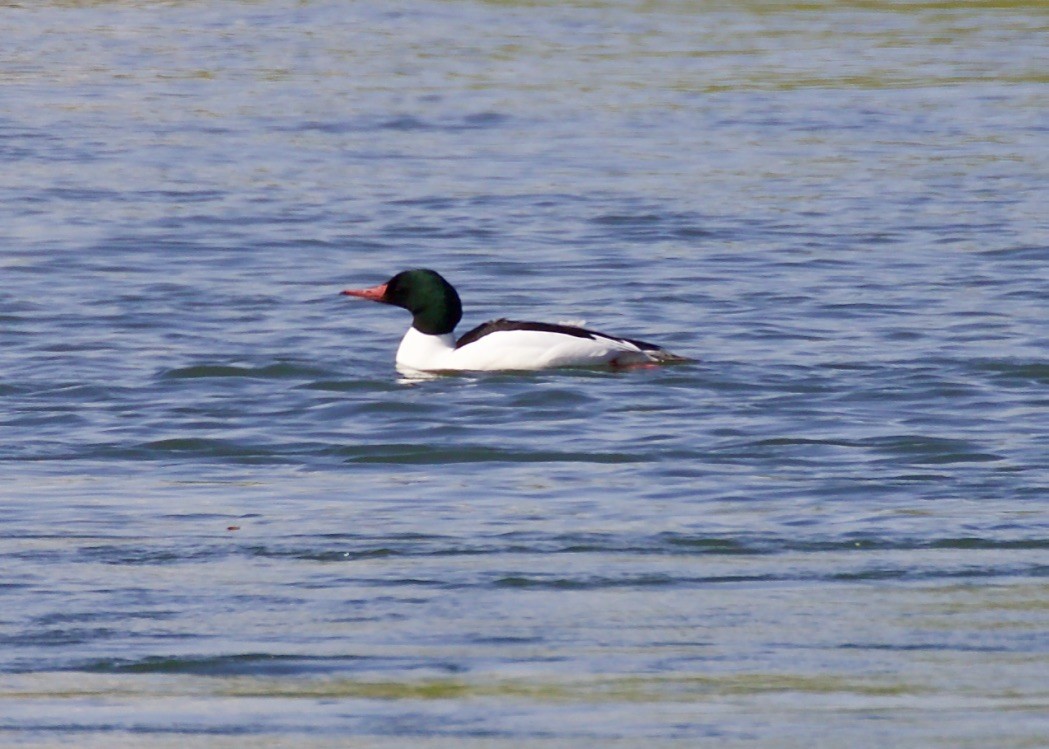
[343,269,688,372]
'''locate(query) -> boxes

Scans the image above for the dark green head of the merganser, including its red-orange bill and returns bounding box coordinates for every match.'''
[343,268,463,336]
